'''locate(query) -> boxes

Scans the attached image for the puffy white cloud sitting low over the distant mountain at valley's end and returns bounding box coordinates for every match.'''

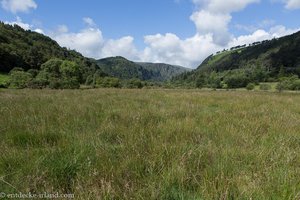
[141,33,220,67]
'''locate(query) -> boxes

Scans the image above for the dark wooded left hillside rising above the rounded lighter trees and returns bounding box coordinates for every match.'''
[0,22,97,79]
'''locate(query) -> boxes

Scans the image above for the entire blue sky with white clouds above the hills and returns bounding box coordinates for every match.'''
[0,0,300,68]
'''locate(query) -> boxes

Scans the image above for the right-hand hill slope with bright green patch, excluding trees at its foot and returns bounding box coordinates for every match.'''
[198,32,300,74]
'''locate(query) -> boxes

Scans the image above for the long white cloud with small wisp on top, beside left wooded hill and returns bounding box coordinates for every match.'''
[50,18,139,60]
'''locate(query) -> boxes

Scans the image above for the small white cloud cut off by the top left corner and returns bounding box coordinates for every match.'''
[1,0,37,14]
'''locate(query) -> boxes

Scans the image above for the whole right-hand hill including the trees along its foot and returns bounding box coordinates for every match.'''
[173,32,300,87]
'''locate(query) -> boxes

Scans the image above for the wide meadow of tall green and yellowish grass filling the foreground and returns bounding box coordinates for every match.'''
[0,89,300,200]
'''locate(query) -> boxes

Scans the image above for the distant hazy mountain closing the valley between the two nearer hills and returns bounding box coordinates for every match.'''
[97,56,189,81]
